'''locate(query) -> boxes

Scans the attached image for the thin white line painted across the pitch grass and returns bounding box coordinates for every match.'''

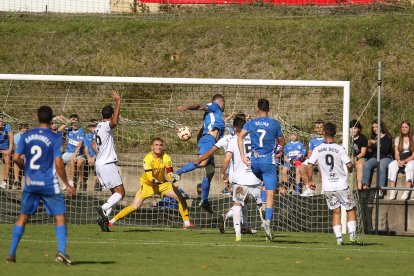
[0,239,414,254]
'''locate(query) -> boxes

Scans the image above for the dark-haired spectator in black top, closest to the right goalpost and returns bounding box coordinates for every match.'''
[349,120,368,190]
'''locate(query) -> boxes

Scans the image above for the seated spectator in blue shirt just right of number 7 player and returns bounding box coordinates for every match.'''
[283,128,306,195]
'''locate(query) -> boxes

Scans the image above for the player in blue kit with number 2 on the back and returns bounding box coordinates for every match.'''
[6,106,76,265]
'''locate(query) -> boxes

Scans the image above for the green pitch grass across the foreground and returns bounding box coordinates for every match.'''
[0,225,414,276]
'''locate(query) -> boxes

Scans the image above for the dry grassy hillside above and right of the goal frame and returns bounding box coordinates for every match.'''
[0,7,414,134]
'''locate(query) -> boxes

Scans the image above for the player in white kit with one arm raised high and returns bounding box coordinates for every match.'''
[92,91,125,232]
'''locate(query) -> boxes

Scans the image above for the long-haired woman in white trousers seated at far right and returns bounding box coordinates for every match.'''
[388,121,414,200]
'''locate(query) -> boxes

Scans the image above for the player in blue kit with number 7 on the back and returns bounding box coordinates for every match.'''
[237,99,286,240]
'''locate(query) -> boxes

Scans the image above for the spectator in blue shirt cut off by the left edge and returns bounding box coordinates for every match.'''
[0,114,13,190]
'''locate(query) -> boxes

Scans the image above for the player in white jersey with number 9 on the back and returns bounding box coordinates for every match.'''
[307,123,363,245]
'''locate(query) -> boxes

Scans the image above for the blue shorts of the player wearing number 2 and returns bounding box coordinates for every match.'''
[20,191,66,216]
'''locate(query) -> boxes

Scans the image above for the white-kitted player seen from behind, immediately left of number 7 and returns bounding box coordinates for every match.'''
[222,118,262,242]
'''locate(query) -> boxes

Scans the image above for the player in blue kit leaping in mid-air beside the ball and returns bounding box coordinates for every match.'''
[173,94,225,213]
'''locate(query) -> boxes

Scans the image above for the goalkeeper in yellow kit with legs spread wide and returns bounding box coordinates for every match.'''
[108,137,193,228]
